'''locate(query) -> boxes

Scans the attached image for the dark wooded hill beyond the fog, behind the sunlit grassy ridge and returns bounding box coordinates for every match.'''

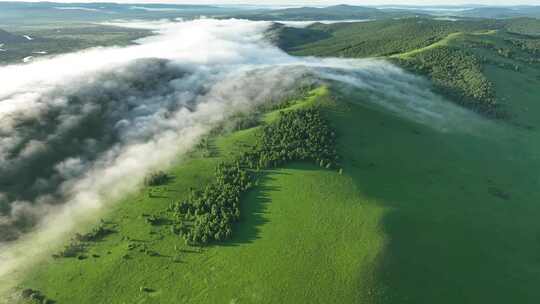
[276,18,503,57]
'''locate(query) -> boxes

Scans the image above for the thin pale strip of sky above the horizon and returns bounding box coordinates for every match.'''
[0,0,540,6]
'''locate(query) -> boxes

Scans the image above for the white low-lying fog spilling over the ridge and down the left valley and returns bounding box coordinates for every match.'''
[0,19,486,294]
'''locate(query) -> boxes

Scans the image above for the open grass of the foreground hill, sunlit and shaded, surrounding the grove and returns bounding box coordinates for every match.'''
[13,53,540,303]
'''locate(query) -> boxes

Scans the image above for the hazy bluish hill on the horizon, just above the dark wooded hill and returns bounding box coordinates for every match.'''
[230,5,424,21]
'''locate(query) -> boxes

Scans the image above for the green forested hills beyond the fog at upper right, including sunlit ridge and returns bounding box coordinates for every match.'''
[270,18,540,117]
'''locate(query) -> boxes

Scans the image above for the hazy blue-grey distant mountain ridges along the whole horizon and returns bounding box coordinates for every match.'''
[0,0,540,28]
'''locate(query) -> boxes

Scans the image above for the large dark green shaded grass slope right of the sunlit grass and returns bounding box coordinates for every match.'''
[326,101,540,304]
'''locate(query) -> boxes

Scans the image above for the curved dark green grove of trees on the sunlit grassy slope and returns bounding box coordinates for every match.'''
[172,109,339,244]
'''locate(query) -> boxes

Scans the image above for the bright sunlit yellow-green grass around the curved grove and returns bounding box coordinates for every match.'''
[23,86,384,303]
